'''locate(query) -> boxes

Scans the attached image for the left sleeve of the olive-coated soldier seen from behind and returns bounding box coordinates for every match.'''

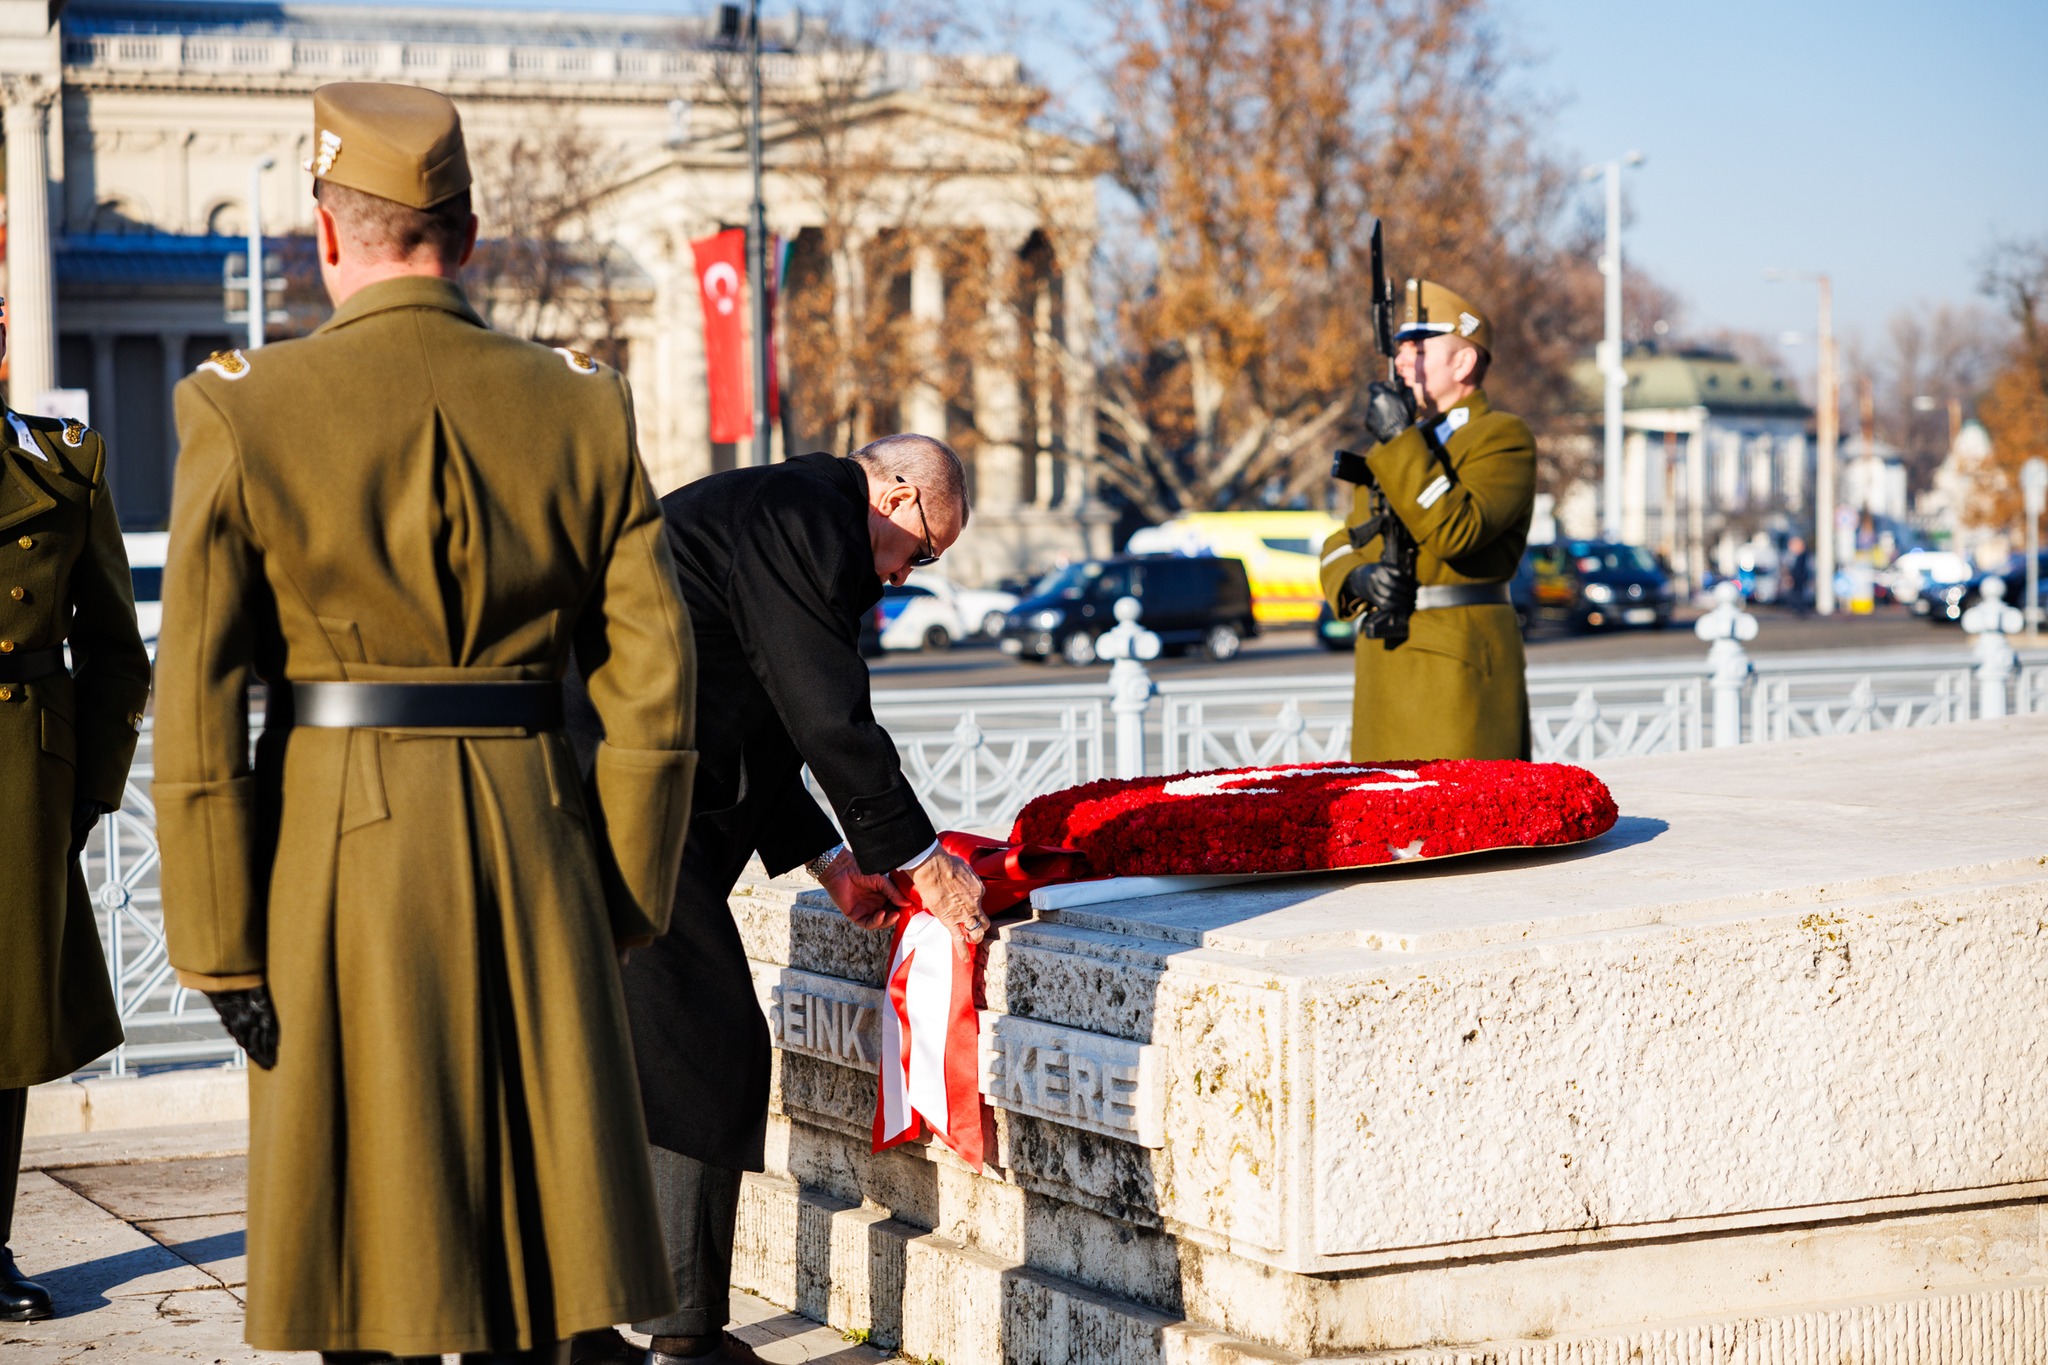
[156,379,270,990]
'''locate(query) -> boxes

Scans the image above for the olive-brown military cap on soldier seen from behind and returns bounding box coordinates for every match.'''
[305,80,469,209]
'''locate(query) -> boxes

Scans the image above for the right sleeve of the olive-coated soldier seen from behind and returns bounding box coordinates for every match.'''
[575,379,696,945]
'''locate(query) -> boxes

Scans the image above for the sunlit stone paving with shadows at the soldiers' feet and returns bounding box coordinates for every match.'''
[0,1124,889,1365]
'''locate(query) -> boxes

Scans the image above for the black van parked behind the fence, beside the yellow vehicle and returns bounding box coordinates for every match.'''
[1001,555,1260,663]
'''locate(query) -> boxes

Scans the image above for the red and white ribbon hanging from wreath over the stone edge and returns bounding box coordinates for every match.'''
[874,831,1090,1166]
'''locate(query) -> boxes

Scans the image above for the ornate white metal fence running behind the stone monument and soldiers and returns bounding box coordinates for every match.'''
[86,613,2048,1072]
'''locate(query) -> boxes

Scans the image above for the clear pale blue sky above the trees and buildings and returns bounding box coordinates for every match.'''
[292,0,2048,358]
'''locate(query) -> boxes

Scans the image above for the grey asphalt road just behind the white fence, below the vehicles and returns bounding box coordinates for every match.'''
[868,606,1968,690]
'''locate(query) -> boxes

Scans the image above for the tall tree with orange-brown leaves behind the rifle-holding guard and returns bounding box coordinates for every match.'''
[1100,0,1599,516]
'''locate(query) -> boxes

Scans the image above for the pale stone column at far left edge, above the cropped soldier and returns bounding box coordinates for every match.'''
[0,76,59,417]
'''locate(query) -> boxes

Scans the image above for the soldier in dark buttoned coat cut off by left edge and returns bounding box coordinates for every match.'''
[0,313,150,1322]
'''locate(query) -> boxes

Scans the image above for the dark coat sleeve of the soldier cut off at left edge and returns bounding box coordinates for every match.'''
[66,436,150,810]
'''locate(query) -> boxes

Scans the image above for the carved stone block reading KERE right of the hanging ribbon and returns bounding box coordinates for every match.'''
[981,1011,1165,1148]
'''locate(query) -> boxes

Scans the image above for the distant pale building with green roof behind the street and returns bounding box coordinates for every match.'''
[1559,346,1812,583]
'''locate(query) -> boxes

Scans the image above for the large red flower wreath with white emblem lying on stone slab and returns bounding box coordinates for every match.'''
[1010,759,1616,876]
